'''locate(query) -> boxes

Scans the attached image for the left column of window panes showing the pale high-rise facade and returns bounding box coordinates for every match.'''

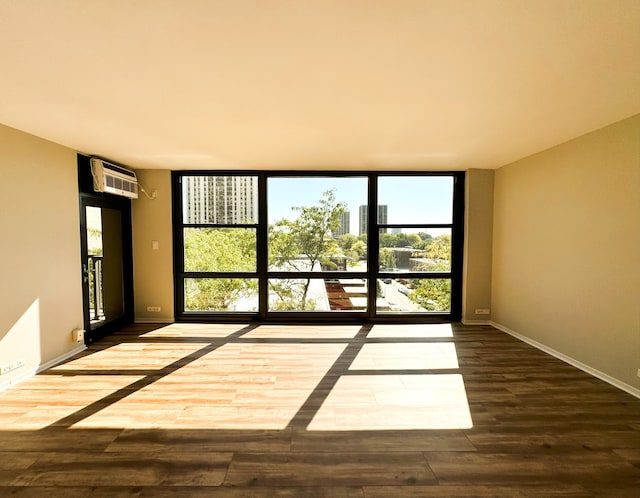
[176,175,259,314]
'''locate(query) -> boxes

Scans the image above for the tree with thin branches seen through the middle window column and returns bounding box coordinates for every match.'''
[269,190,346,310]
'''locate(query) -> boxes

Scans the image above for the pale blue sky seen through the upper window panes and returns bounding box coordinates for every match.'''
[267,176,453,235]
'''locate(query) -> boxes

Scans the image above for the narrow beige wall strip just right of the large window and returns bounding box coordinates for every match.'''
[462,169,494,323]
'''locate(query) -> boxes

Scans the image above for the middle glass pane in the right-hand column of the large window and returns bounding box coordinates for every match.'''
[379,228,451,272]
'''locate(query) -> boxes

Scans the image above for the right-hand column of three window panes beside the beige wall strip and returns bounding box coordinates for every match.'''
[376,176,455,313]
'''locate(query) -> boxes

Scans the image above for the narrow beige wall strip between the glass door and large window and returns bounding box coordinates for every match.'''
[132,170,174,322]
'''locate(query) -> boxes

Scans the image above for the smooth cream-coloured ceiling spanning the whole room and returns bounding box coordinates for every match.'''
[0,0,640,170]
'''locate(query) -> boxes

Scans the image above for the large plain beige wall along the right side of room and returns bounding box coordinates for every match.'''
[492,115,640,389]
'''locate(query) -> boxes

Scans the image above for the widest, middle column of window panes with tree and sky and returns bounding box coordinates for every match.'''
[267,176,369,314]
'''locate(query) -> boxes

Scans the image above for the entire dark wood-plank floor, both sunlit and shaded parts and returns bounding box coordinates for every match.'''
[0,324,640,498]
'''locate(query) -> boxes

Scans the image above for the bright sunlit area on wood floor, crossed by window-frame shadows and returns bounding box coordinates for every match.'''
[0,324,472,431]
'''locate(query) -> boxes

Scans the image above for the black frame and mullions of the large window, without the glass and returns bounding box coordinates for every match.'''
[172,170,465,323]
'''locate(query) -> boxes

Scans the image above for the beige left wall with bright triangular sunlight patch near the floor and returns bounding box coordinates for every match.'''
[0,125,82,387]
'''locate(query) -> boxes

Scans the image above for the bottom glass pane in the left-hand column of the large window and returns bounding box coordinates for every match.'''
[184,278,258,311]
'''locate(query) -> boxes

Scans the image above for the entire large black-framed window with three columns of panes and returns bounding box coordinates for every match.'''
[173,171,464,321]
